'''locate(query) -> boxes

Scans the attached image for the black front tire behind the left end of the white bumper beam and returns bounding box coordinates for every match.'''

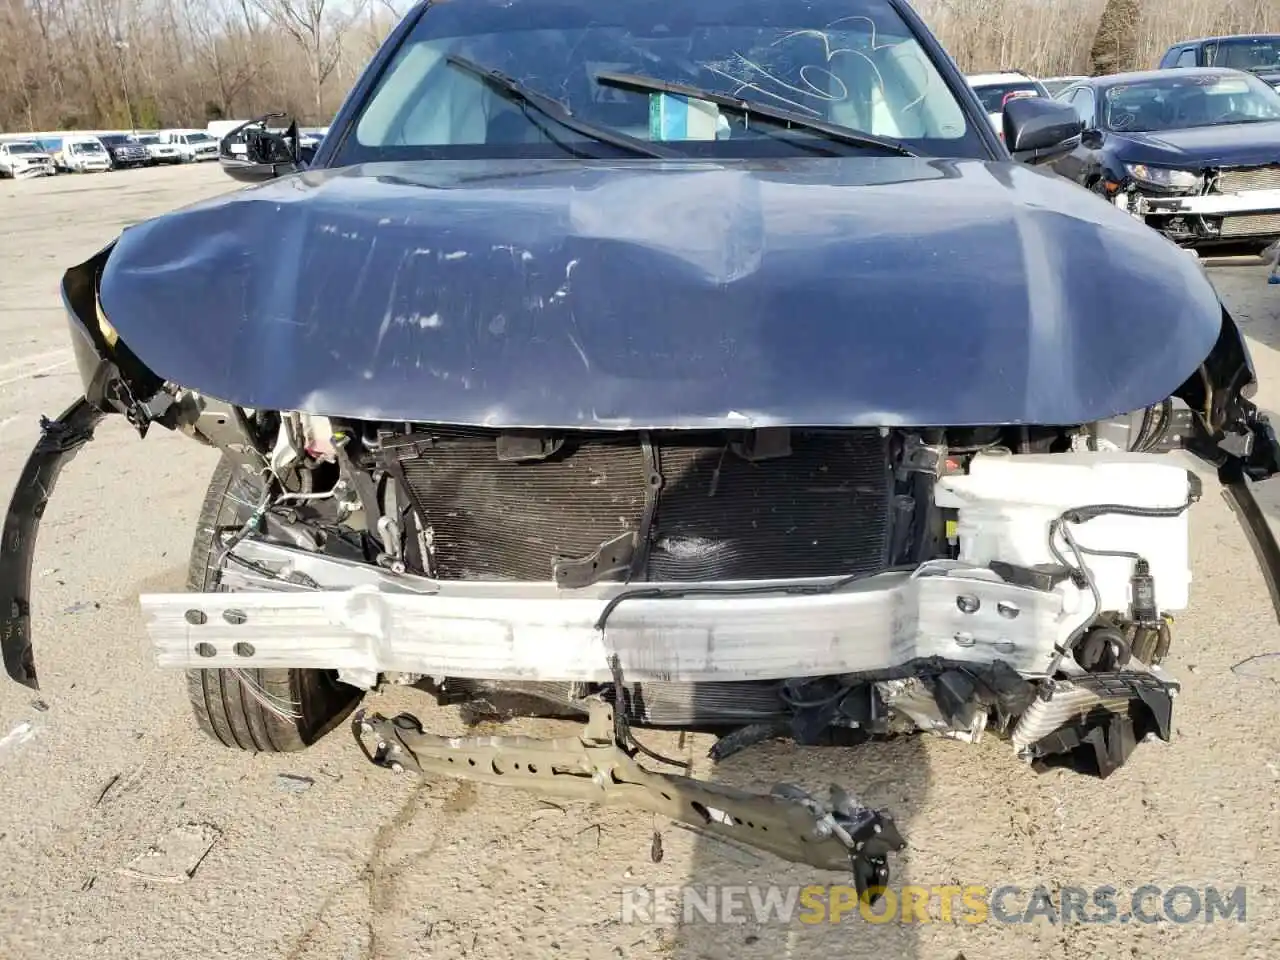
[187,457,361,753]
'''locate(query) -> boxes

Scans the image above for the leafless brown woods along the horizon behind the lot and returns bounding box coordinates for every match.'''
[0,0,1280,131]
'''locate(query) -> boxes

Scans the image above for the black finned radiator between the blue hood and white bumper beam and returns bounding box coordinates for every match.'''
[383,428,891,581]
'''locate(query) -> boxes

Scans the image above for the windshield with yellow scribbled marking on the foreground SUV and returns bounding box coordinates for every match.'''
[334,0,989,164]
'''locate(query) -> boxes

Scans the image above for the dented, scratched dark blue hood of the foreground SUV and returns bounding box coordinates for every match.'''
[100,157,1222,429]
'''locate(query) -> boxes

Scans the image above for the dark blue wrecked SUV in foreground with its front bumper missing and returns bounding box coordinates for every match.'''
[0,0,1280,888]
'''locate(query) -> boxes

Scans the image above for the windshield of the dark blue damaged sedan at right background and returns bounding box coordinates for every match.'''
[1102,74,1280,132]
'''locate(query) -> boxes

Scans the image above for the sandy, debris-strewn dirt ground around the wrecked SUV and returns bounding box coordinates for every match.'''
[0,166,1280,960]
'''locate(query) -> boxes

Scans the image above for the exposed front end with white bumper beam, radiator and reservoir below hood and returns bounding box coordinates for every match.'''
[162,393,1199,774]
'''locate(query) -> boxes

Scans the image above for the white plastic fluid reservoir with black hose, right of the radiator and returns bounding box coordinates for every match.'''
[934,451,1192,612]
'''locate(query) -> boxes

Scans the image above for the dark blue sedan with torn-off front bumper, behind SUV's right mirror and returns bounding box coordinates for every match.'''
[1052,67,1280,246]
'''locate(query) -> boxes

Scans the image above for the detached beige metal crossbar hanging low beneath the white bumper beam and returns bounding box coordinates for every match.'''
[352,696,906,902]
